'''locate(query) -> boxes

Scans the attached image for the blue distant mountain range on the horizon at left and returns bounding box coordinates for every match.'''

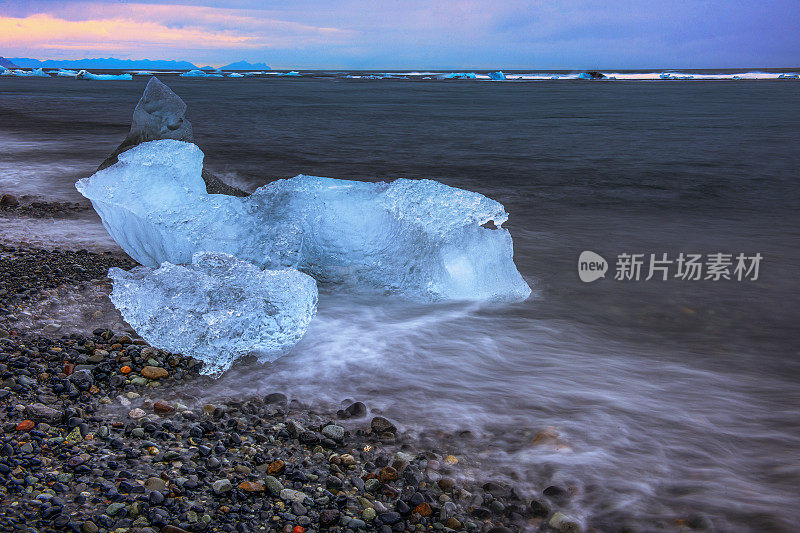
[6,57,270,70]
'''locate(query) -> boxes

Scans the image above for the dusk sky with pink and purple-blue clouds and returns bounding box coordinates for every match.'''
[0,0,800,69]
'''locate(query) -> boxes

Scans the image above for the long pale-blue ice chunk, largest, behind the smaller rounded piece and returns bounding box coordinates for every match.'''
[76,140,531,301]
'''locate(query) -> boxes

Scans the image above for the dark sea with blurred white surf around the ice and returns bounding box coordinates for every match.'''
[0,75,800,531]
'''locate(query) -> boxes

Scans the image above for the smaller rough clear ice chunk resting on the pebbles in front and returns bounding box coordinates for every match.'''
[108,252,317,374]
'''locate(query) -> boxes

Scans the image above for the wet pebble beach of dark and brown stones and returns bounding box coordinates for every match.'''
[0,243,582,533]
